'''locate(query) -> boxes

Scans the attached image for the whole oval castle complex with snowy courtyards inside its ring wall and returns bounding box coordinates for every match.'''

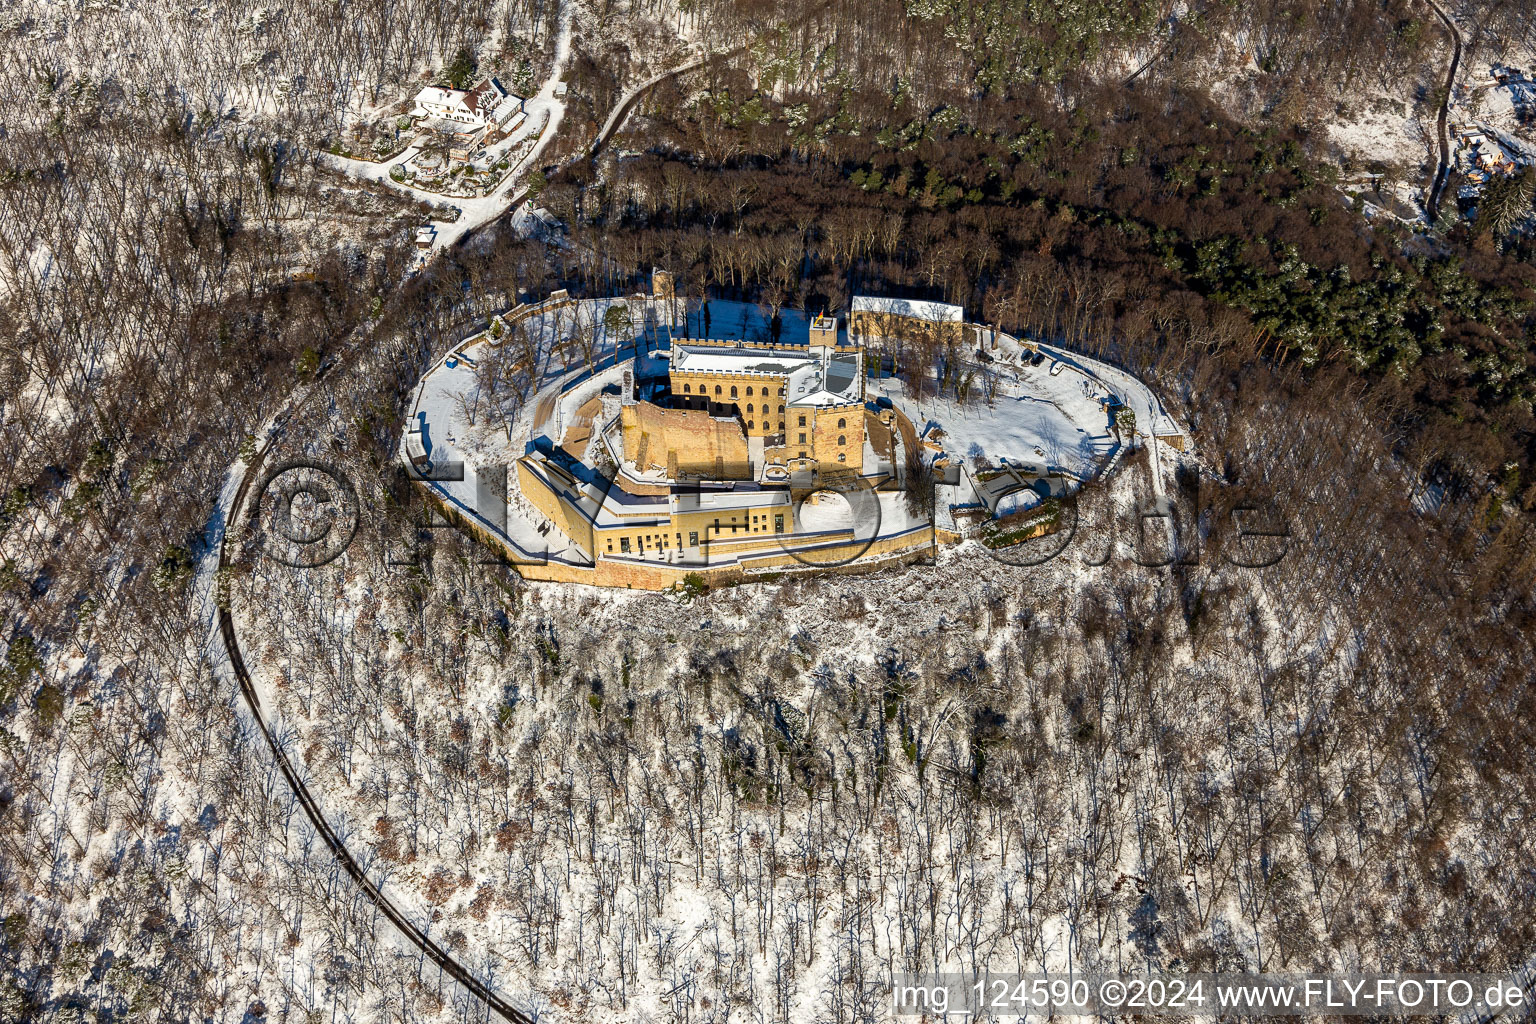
[402,272,1181,590]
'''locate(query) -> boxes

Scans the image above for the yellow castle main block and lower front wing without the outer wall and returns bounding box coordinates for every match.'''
[518,328,884,568]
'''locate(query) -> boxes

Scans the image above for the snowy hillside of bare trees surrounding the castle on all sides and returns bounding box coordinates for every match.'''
[0,0,1536,1024]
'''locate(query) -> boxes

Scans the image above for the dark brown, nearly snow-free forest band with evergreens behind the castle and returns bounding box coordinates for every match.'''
[562,46,1536,497]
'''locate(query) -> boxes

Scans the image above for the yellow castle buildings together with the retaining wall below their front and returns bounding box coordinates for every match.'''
[497,296,934,586]
